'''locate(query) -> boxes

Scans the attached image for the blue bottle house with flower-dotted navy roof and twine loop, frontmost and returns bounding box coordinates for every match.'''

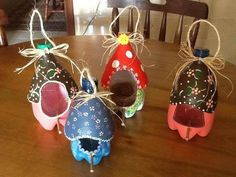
[64,68,114,172]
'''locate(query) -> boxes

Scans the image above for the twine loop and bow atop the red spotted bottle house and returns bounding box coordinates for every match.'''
[101,5,150,65]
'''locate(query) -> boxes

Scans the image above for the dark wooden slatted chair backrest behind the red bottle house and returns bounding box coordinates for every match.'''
[107,0,208,47]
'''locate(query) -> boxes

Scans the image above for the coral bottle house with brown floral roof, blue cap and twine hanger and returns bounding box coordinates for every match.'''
[168,20,231,140]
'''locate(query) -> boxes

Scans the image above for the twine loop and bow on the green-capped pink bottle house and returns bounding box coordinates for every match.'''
[15,9,81,74]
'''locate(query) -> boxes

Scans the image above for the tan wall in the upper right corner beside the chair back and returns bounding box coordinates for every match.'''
[195,0,236,64]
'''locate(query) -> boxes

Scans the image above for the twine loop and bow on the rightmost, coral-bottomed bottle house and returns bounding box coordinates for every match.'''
[173,20,234,97]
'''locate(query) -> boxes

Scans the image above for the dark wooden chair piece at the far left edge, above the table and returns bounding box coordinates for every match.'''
[0,9,8,46]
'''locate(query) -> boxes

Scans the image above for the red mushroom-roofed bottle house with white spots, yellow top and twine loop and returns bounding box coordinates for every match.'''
[101,6,148,118]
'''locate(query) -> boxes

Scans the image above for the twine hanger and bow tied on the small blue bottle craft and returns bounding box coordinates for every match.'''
[73,68,125,127]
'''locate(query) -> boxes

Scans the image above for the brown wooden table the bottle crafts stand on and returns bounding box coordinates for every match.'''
[0,36,236,177]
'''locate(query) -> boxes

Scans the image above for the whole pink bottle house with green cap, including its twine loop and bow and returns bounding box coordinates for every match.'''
[16,10,78,134]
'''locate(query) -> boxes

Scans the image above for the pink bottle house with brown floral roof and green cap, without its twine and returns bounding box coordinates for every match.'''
[27,43,78,132]
